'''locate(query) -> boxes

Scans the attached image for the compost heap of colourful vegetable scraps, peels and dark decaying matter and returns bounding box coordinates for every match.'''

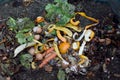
[0,0,120,80]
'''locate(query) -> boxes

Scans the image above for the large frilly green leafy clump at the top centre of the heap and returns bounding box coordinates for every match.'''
[45,0,75,26]
